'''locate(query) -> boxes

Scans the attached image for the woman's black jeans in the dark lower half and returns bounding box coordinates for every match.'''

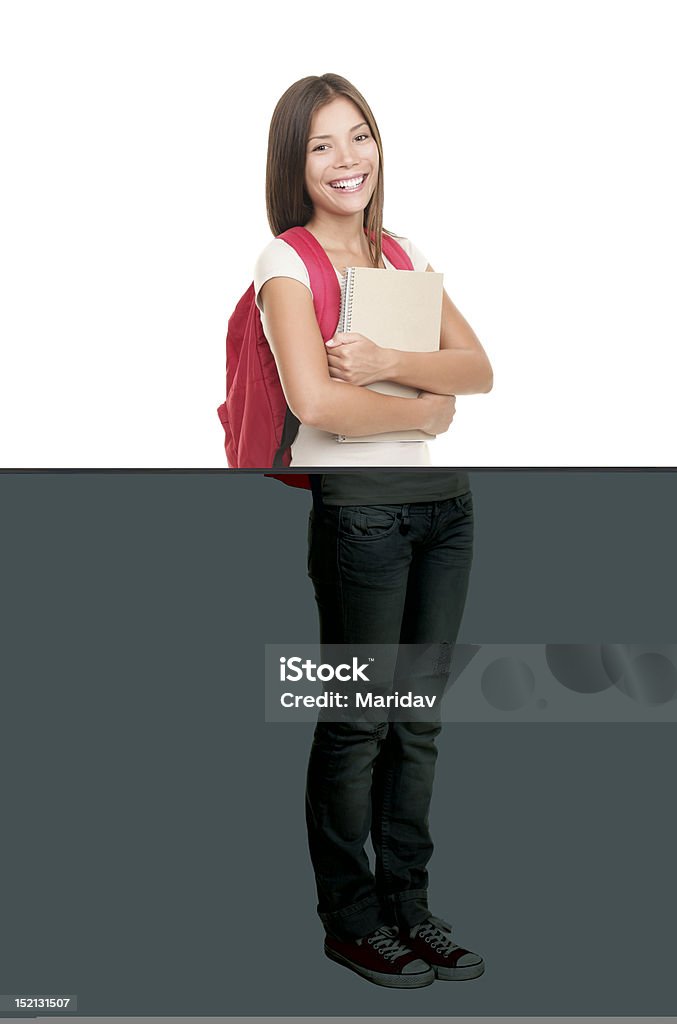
[306,493,473,940]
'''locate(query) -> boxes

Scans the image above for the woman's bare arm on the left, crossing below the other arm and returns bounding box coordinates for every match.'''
[260,278,455,437]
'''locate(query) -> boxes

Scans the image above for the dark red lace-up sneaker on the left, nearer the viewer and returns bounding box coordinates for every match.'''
[325,927,435,988]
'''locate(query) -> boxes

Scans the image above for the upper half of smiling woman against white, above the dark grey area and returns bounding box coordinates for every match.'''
[254,75,492,467]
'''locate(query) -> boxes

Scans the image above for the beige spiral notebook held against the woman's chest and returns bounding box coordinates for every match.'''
[337,266,442,443]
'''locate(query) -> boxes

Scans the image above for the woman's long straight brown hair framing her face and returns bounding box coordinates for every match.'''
[265,75,383,266]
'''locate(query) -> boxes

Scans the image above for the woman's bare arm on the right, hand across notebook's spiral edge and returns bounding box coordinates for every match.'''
[327,264,494,394]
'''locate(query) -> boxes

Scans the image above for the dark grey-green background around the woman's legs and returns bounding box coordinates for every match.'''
[0,471,677,1017]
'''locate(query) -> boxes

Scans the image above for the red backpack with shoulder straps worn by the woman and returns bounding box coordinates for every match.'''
[217,227,414,471]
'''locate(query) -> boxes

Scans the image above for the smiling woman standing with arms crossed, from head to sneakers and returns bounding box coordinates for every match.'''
[261,75,492,988]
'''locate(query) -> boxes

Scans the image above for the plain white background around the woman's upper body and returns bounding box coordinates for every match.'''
[0,0,677,467]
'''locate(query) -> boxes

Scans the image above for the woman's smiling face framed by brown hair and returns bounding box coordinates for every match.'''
[305,96,379,223]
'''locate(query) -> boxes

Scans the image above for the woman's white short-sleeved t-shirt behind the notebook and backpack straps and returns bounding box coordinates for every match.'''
[254,234,430,466]
